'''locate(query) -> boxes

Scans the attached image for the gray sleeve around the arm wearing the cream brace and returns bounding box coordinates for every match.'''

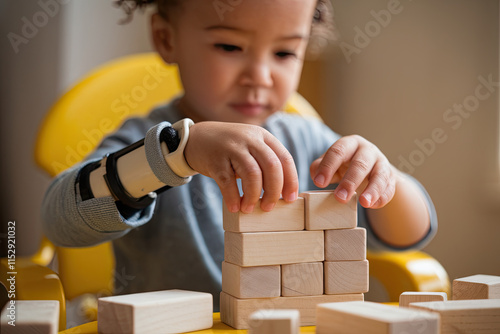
[41,110,182,247]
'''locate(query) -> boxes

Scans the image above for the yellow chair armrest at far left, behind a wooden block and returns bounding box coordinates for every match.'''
[0,258,66,330]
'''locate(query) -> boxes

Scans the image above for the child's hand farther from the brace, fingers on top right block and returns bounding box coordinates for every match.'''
[310,135,398,209]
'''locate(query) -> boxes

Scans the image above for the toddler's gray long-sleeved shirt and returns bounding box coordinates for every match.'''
[42,103,437,311]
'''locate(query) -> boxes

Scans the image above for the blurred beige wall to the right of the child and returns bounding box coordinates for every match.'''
[322,0,500,278]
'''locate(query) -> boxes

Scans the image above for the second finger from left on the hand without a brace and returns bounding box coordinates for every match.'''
[335,147,376,202]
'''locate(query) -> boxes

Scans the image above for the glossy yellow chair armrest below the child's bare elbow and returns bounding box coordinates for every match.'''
[367,251,450,302]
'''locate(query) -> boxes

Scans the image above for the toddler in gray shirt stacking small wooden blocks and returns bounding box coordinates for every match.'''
[42,0,437,310]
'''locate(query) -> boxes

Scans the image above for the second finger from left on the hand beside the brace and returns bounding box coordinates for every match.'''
[231,152,262,213]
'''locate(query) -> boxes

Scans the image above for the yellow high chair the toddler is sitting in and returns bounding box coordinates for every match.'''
[0,53,450,330]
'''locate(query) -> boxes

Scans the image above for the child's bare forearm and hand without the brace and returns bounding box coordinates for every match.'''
[310,136,430,248]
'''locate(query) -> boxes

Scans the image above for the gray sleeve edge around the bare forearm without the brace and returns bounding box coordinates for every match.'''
[358,175,438,251]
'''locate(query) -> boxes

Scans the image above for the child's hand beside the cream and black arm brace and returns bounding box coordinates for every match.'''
[184,122,299,213]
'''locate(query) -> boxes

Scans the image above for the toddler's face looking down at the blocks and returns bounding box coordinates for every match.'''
[153,0,316,125]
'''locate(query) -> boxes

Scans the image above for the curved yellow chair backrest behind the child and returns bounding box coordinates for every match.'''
[35,53,319,299]
